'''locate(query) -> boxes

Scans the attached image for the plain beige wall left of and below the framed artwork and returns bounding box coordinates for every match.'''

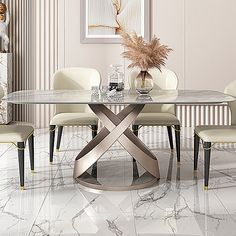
[61,0,124,83]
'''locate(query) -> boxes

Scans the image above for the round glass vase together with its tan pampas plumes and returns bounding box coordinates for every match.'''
[121,32,172,94]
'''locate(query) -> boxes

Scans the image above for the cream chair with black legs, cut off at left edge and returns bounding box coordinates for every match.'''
[0,86,34,190]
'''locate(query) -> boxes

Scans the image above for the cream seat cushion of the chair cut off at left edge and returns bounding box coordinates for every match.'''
[0,125,34,143]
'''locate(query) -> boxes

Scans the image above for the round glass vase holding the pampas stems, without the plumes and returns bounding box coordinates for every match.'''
[134,70,154,94]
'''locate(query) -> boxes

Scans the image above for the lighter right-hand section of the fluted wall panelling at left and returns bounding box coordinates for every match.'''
[34,0,58,127]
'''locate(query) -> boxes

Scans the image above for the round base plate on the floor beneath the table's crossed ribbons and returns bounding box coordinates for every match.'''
[76,159,158,191]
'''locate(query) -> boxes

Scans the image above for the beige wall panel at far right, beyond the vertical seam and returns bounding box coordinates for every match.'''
[185,0,236,90]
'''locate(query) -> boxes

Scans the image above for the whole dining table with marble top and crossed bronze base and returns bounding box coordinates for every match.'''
[5,90,235,190]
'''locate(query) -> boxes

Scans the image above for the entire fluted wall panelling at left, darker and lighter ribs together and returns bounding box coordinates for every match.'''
[2,0,61,127]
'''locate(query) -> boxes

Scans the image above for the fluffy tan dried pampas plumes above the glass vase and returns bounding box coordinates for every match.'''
[121,33,172,71]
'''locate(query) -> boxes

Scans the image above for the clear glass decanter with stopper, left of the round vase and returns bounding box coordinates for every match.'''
[108,65,124,91]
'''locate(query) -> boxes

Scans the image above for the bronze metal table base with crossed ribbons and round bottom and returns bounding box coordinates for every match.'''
[73,104,160,191]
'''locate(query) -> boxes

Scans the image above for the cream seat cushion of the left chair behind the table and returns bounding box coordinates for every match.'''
[50,113,98,126]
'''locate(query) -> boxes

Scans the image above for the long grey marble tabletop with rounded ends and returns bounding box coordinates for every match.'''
[5,90,235,104]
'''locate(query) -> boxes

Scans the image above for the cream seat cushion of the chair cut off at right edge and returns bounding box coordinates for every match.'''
[195,125,236,143]
